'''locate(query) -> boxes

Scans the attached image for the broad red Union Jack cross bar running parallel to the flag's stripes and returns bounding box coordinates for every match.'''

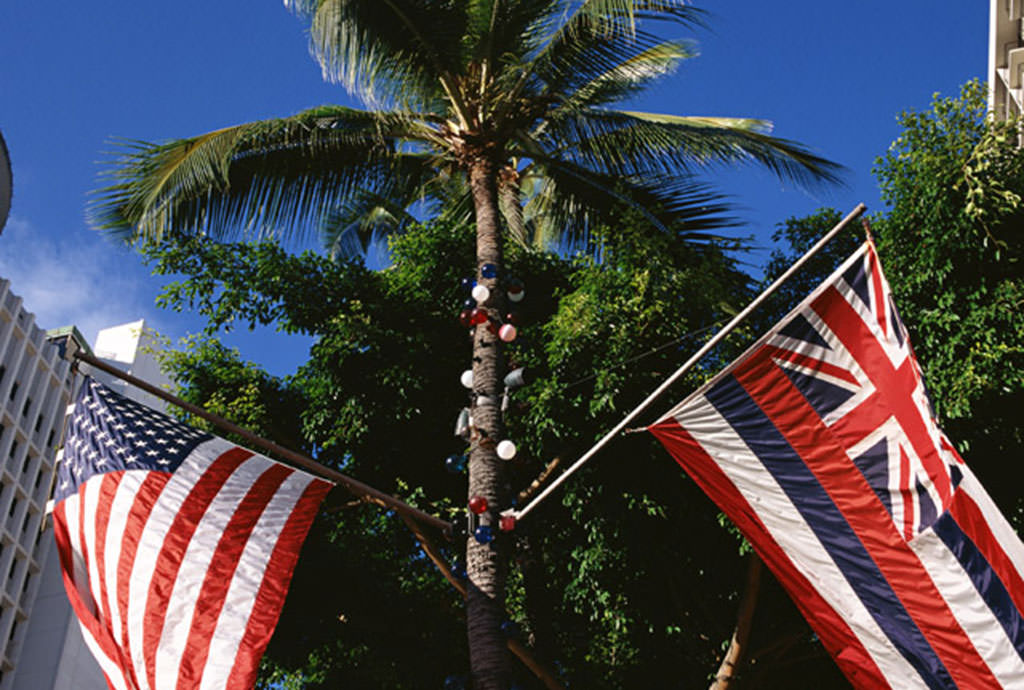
[811,287,952,506]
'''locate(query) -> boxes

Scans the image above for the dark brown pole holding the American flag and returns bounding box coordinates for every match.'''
[71,350,452,536]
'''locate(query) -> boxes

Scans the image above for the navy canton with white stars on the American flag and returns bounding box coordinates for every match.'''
[53,378,213,502]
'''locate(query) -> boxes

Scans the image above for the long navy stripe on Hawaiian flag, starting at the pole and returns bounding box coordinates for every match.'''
[706,376,956,688]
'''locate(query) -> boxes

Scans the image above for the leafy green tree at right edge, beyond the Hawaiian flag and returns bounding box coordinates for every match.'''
[876,82,1024,515]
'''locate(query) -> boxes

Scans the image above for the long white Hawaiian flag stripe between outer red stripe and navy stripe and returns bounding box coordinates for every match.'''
[674,395,927,690]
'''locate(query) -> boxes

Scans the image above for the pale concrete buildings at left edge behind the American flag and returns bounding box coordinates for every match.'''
[0,278,170,690]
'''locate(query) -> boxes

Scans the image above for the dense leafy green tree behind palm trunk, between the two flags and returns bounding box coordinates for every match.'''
[152,214,847,689]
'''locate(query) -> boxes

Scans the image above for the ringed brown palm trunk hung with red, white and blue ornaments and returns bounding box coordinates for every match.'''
[466,156,509,690]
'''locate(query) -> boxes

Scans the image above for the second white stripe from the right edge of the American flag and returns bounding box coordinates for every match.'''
[151,456,273,690]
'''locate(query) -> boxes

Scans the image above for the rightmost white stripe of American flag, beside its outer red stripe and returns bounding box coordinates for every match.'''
[200,472,314,690]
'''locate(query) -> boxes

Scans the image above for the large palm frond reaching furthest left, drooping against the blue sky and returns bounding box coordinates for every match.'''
[88,106,438,242]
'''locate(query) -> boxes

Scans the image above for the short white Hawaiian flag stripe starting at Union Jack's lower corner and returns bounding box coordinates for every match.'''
[910,528,1024,688]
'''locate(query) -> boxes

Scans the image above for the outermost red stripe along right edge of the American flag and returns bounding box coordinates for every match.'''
[224,479,333,690]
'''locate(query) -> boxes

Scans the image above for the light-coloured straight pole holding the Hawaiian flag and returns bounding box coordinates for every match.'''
[502,204,867,520]
